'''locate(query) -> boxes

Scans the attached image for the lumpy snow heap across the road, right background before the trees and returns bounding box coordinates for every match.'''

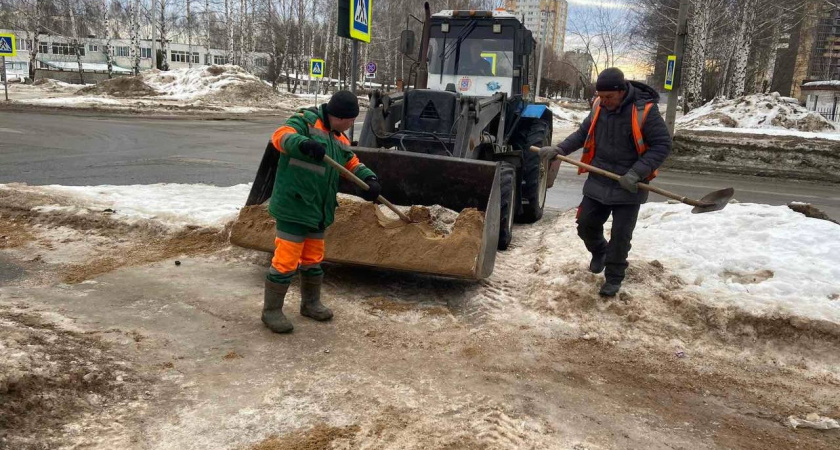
[677,92,837,132]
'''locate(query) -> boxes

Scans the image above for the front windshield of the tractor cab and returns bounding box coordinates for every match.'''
[429,23,513,78]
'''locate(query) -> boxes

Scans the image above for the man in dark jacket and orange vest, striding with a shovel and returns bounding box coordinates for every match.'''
[540,67,672,297]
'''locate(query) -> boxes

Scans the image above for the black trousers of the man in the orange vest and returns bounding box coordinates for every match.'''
[577,196,641,283]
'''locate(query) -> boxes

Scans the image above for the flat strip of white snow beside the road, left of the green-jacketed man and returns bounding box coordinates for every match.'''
[19,183,251,227]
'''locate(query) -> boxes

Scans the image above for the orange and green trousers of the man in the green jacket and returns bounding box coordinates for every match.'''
[268,230,325,281]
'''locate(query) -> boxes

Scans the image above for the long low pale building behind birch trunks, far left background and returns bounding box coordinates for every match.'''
[0,30,269,79]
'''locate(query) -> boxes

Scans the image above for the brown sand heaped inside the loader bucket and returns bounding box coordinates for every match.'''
[230,196,484,278]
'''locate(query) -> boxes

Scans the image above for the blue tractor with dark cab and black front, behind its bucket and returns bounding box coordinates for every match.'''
[358,3,559,250]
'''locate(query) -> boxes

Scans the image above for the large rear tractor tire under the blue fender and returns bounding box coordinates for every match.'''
[512,120,551,223]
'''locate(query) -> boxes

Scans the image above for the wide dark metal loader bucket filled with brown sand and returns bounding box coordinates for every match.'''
[231,147,500,280]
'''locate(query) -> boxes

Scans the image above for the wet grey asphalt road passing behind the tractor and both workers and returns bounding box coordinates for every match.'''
[0,111,840,220]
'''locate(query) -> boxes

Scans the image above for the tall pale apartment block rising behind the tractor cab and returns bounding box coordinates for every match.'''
[505,0,569,56]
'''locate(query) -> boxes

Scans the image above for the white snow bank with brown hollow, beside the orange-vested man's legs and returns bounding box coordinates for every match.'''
[631,203,840,324]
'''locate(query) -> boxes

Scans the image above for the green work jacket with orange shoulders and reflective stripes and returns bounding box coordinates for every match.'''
[268,105,374,230]
